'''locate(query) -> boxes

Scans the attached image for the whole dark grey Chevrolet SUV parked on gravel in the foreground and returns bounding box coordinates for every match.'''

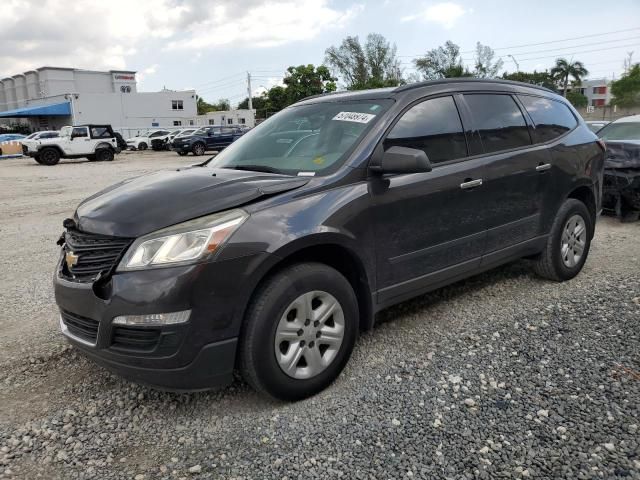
[54,79,604,400]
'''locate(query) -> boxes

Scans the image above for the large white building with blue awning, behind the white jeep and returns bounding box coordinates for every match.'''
[0,67,197,137]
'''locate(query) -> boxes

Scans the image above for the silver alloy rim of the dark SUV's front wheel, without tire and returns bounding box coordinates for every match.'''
[274,290,345,380]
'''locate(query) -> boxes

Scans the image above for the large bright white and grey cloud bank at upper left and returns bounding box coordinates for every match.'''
[0,0,362,77]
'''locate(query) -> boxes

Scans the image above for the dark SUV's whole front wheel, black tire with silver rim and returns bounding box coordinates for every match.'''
[239,263,359,401]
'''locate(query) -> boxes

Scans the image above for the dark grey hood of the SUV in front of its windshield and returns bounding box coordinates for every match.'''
[76,167,309,238]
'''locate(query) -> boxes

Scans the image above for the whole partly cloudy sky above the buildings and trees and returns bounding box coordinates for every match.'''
[0,0,640,104]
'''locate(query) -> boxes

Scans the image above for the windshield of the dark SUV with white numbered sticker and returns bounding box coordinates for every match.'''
[208,100,392,176]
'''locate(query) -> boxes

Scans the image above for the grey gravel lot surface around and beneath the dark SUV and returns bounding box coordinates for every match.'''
[0,152,640,480]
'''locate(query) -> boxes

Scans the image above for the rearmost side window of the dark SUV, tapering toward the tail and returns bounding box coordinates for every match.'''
[519,95,577,143]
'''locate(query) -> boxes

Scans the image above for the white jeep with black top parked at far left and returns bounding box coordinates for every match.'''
[22,125,120,165]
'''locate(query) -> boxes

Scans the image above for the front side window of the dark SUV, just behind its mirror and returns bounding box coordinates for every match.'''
[384,97,467,163]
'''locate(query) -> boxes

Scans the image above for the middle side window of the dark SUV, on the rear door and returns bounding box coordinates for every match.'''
[464,94,531,153]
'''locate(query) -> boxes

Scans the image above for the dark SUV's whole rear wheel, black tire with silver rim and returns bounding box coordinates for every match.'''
[534,198,594,282]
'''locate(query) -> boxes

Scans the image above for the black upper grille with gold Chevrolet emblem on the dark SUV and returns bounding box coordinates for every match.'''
[62,230,131,282]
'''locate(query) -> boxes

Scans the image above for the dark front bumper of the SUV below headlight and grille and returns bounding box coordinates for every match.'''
[54,254,267,390]
